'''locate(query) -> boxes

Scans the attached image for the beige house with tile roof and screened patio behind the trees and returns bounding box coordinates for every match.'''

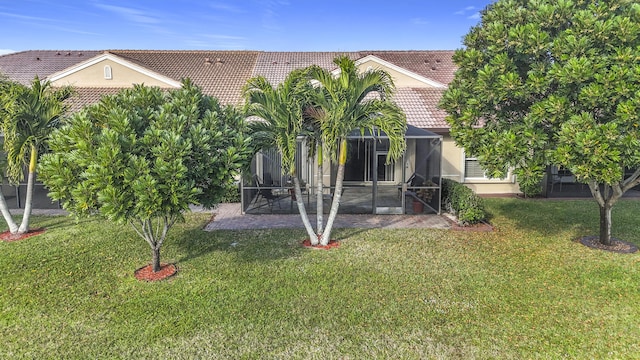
[0,50,519,213]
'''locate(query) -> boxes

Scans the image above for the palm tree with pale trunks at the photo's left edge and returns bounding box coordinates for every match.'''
[0,76,72,234]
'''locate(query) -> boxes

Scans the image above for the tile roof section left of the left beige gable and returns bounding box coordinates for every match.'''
[0,50,102,85]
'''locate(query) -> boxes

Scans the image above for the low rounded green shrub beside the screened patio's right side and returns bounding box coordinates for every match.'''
[442,179,487,224]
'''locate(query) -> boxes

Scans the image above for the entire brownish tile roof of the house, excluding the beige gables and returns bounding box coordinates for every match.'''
[0,50,456,129]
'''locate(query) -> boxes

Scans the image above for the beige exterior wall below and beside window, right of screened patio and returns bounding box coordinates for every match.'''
[442,135,520,195]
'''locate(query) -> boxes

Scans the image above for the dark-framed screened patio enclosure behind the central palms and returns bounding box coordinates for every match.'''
[241,126,442,214]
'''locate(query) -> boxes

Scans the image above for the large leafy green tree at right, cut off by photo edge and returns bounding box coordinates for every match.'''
[441,0,640,245]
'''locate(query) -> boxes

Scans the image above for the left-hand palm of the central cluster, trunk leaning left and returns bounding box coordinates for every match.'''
[243,70,318,241]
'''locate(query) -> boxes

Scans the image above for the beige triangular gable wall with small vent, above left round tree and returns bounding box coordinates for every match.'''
[52,59,168,88]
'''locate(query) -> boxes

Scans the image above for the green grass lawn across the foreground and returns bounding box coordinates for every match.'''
[0,199,640,359]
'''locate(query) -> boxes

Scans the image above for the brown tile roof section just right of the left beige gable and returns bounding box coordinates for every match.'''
[109,50,259,104]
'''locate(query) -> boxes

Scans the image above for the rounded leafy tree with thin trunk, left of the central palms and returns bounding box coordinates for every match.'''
[40,80,250,271]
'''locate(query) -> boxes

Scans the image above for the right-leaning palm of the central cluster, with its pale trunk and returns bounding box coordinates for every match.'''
[309,56,407,245]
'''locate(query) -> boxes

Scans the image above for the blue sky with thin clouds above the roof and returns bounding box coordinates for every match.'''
[0,0,491,53]
